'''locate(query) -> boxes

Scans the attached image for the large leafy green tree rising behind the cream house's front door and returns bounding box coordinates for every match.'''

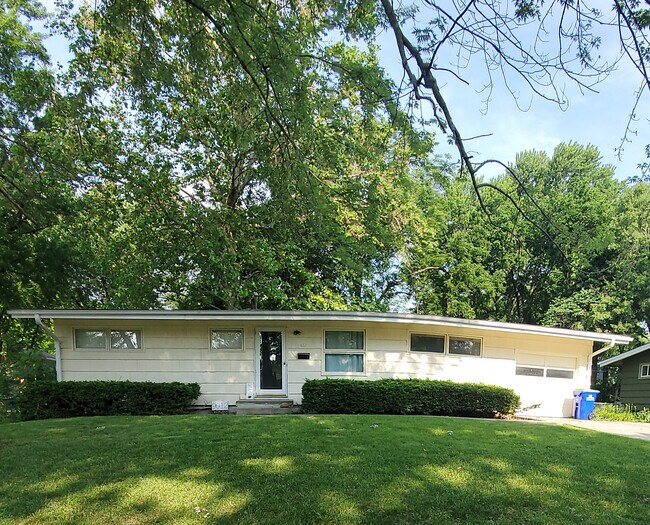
[48,1,431,309]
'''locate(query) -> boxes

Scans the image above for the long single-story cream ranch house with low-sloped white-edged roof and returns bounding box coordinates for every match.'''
[9,310,631,417]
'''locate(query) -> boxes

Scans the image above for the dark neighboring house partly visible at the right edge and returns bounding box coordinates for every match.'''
[599,343,650,408]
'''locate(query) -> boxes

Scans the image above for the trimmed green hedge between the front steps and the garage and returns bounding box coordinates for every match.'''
[302,379,520,417]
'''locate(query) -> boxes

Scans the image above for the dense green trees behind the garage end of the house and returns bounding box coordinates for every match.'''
[405,144,647,336]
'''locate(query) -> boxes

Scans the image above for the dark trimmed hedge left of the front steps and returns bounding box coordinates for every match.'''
[18,381,201,419]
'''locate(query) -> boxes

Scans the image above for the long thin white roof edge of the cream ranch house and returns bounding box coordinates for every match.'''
[8,309,632,345]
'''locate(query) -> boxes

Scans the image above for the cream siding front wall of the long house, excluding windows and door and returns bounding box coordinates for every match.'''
[56,319,592,417]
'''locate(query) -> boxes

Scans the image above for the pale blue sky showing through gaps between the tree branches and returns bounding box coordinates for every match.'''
[38,0,650,179]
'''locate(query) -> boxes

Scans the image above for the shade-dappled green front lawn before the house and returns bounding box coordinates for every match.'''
[0,416,650,525]
